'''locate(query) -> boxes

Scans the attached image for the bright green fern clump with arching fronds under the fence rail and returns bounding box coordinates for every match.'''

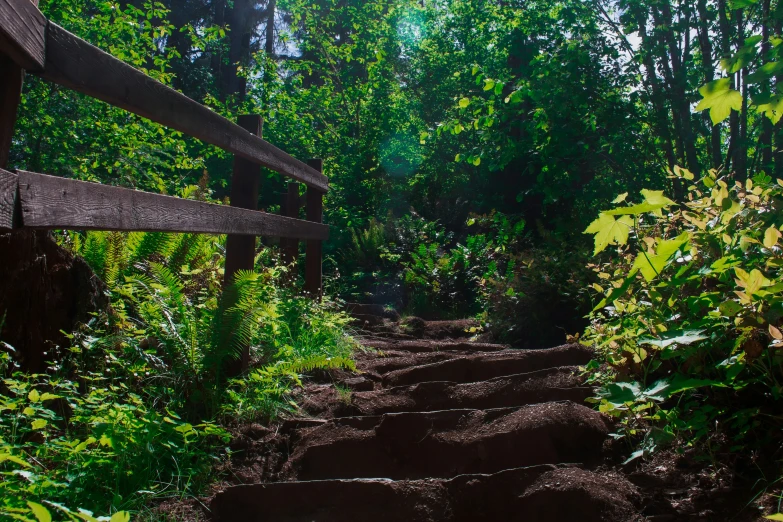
[60,232,354,417]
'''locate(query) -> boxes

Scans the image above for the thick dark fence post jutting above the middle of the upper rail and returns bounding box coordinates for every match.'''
[223,114,263,286]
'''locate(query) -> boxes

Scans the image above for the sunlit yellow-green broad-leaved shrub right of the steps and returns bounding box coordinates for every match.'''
[583,168,783,458]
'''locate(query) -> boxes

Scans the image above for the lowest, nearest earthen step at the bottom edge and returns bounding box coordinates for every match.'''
[210,465,639,522]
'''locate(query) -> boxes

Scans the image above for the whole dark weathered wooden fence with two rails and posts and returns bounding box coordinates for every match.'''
[0,0,329,296]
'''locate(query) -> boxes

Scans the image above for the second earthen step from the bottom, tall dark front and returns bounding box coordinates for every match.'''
[281,402,609,480]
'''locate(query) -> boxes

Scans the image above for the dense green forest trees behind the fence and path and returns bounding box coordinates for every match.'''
[11,0,783,322]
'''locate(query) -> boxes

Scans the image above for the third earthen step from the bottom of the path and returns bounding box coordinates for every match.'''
[303,366,593,417]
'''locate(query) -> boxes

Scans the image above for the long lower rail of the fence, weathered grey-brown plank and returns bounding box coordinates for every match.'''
[18,171,329,239]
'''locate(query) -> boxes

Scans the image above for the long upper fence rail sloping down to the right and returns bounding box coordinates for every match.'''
[39,23,328,192]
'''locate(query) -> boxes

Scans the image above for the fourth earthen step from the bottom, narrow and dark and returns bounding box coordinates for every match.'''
[376,344,593,386]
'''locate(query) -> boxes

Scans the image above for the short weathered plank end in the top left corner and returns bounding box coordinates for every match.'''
[0,0,46,71]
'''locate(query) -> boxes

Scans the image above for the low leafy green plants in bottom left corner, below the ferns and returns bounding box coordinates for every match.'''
[0,368,228,520]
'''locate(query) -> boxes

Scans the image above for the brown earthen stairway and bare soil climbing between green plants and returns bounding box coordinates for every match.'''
[158,308,772,522]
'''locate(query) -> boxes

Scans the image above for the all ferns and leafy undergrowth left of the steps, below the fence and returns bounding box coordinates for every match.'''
[0,232,355,522]
